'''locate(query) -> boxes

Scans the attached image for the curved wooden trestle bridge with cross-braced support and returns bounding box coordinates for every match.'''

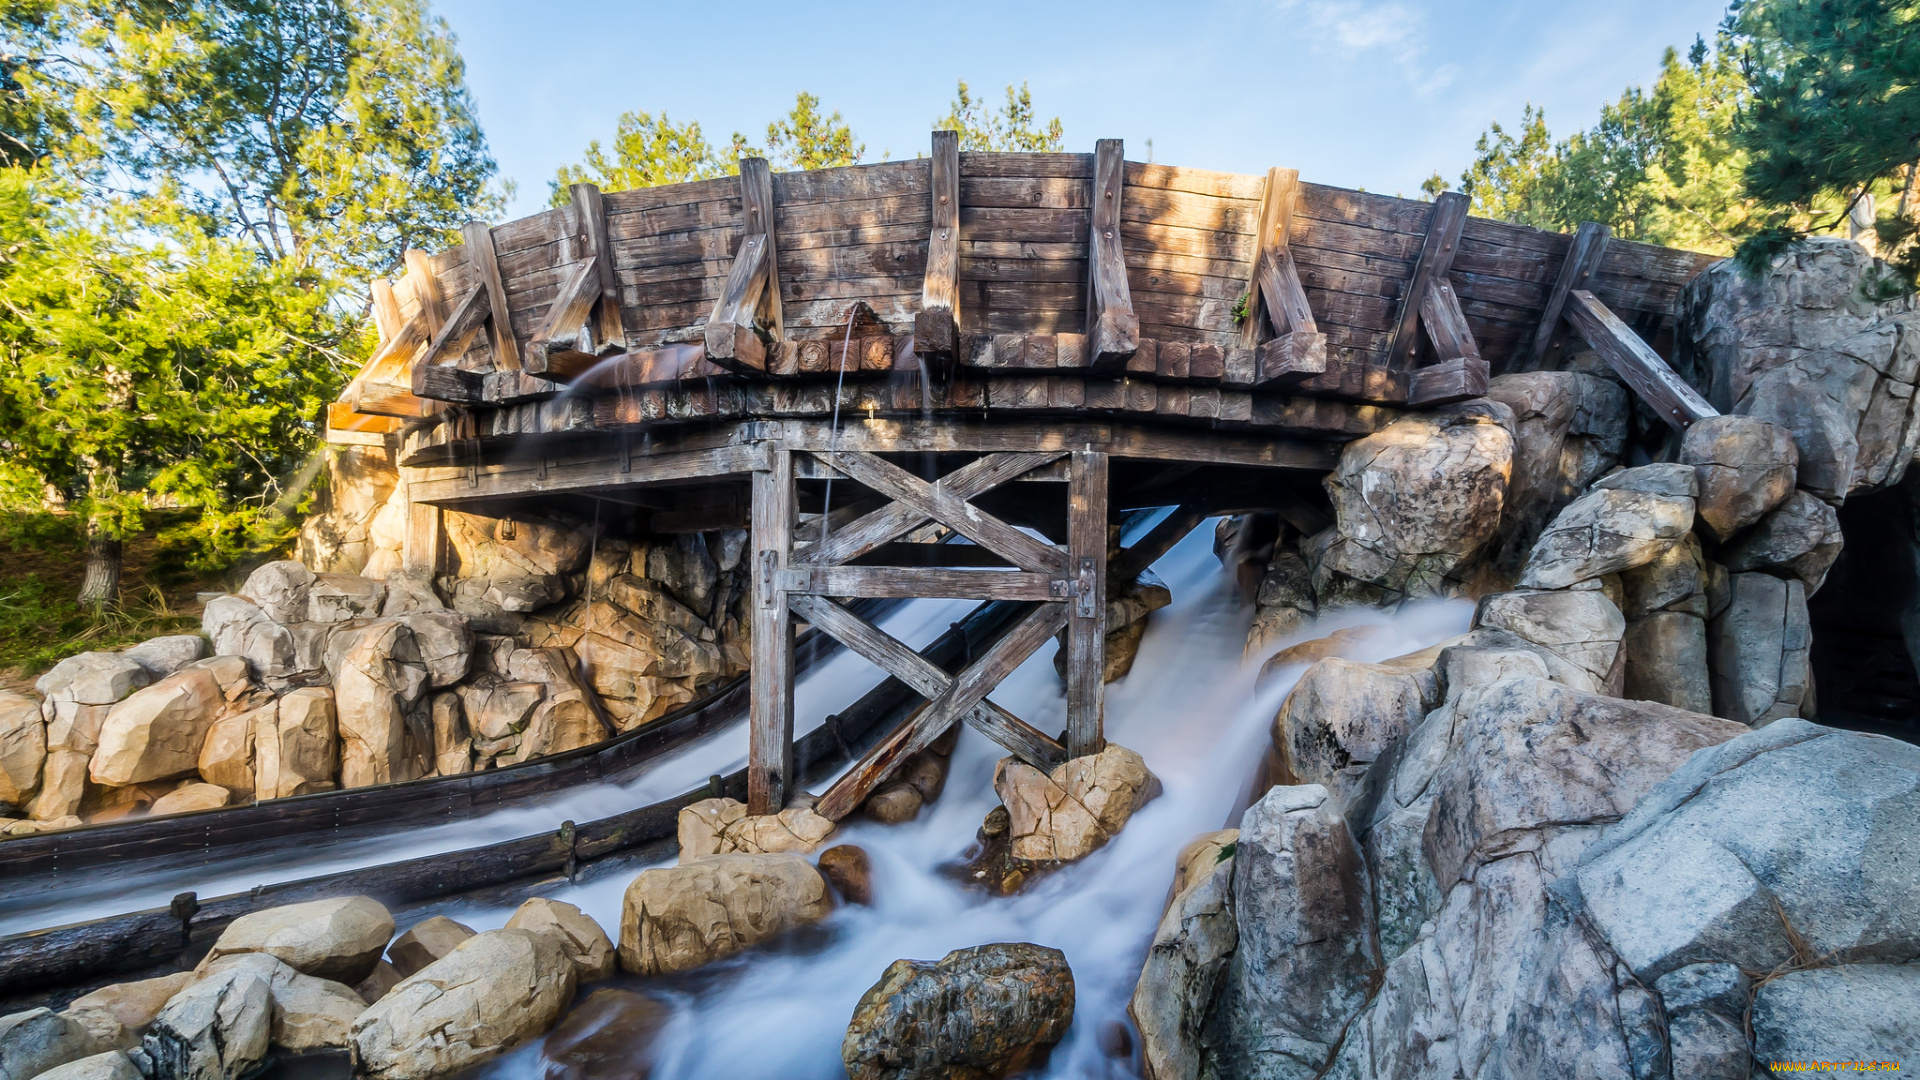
[326,133,1709,817]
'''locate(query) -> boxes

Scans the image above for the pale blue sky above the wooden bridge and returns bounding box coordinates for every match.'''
[434,0,1724,215]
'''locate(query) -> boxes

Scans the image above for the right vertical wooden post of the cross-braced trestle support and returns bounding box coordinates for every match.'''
[1068,450,1106,757]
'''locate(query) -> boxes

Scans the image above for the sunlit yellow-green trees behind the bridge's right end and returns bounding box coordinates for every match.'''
[1451,40,1749,252]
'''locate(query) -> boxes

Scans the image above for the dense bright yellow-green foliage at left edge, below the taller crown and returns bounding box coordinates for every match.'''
[0,169,355,567]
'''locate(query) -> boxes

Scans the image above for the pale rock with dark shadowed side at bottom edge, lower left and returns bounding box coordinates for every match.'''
[140,969,273,1080]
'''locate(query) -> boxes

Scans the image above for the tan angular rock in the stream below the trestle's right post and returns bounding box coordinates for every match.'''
[993,744,1158,863]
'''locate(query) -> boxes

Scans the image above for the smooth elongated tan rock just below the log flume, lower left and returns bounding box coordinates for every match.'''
[202,896,394,986]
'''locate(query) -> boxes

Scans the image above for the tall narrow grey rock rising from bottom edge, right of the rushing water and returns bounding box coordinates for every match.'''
[1202,784,1380,1078]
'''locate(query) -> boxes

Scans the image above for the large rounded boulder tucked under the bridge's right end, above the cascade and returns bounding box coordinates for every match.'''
[1315,400,1513,600]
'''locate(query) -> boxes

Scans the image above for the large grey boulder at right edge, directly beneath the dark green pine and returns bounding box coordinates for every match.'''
[1676,236,1920,499]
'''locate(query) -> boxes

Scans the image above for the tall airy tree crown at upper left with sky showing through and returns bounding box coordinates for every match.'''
[21,0,501,286]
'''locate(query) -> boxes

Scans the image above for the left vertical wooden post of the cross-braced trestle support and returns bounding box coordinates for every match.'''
[747,450,793,813]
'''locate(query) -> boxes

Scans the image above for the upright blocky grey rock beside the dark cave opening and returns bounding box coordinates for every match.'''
[1707,573,1812,726]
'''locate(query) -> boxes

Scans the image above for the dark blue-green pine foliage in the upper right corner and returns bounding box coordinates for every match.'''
[1726,0,1920,279]
